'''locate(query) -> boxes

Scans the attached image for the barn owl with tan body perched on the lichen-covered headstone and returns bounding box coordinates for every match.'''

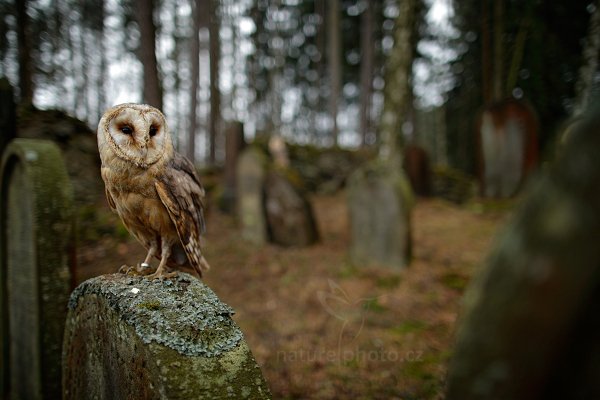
[97,103,209,279]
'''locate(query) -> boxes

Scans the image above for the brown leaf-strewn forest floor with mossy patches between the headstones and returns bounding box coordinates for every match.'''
[77,192,510,399]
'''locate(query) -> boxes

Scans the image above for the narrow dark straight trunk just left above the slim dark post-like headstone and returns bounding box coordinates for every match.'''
[208,0,221,165]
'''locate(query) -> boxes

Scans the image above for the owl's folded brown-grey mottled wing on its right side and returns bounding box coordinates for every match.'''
[155,153,210,276]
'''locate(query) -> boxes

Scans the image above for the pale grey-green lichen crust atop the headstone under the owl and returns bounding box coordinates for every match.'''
[69,273,243,357]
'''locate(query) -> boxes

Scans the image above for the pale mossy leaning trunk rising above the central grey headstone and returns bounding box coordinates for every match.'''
[380,0,415,162]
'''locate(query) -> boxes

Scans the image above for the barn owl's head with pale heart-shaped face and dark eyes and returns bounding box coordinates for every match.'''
[98,103,173,168]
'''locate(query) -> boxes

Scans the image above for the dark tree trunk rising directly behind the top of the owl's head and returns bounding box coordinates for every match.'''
[135,0,162,109]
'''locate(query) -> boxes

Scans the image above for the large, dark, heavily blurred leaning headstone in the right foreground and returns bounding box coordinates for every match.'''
[447,113,600,400]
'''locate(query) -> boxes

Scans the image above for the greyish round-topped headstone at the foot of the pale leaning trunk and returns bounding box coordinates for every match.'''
[348,160,413,268]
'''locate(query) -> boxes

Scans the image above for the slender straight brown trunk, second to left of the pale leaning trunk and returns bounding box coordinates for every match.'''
[327,0,342,146]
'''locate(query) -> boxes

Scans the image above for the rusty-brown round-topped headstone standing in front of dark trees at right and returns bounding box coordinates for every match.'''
[479,100,537,198]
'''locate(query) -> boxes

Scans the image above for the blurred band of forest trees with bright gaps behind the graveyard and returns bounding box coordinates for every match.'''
[0,0,598,174]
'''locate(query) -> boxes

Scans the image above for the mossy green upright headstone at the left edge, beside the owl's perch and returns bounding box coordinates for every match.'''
[0,139,73,399]
